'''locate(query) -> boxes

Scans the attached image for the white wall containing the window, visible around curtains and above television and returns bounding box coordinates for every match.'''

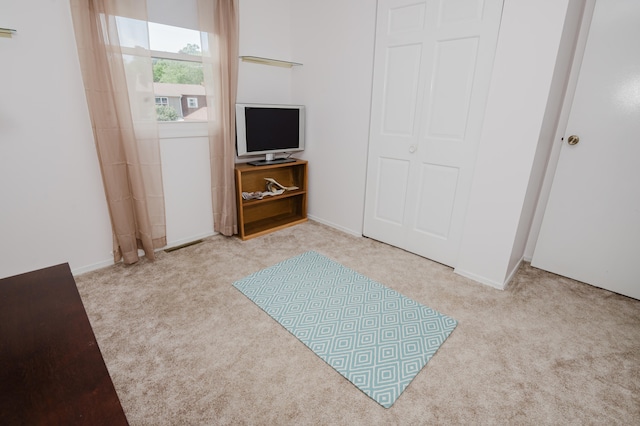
[0,0,293,277]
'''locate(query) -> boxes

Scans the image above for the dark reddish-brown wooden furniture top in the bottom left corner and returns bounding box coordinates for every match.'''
[0,264,128,425]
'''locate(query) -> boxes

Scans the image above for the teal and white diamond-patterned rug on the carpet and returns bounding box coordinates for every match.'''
[233,251,457,408]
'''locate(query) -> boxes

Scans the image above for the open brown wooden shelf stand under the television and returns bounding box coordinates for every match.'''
[235,160,307,240]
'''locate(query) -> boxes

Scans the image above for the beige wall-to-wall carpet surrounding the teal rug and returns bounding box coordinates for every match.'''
[76,222,640,425]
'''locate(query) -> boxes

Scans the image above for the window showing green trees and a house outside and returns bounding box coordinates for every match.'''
[118,17,207,121]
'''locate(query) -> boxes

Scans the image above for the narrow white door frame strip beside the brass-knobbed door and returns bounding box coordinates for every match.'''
[524,0,596,262]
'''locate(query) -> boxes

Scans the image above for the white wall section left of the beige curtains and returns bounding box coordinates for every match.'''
[0,0,113,277]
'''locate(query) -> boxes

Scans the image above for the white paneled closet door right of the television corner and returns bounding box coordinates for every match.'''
[364,0,503,266]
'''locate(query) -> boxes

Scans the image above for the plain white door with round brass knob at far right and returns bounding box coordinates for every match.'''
[531,0,640,299]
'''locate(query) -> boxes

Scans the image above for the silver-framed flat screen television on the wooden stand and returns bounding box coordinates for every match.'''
[236,104,305,165]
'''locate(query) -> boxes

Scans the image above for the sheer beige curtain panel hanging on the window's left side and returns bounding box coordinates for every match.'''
[71,0,166,264]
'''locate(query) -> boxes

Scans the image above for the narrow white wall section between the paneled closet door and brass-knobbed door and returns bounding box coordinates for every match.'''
[455,0,573,288]
